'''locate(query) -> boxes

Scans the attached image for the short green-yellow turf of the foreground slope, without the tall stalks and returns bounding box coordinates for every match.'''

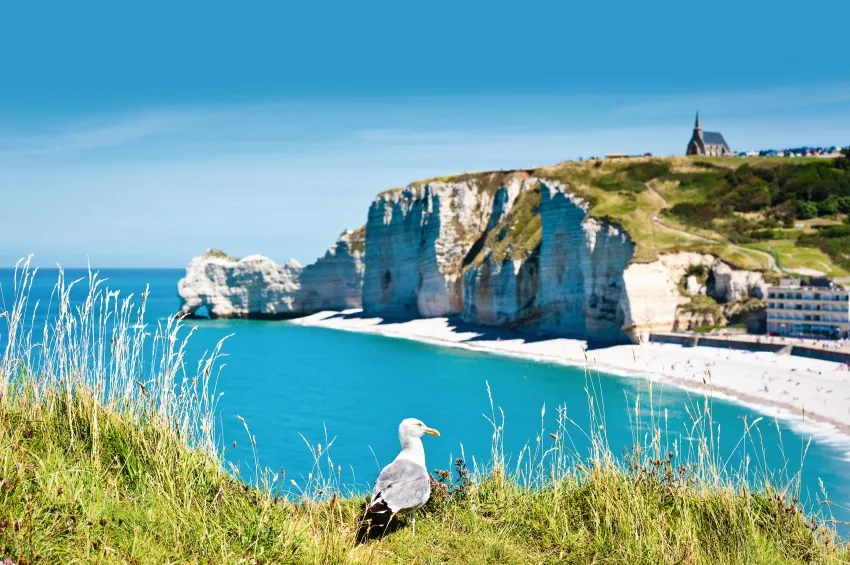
[6,399,850,565]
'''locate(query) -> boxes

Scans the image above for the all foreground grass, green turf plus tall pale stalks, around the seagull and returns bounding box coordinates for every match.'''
[0,261,850,565]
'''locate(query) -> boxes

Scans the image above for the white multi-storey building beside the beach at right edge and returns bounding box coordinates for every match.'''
[767,278,850,339]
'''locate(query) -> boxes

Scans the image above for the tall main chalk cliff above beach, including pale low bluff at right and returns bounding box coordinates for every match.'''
[363,172,764,341]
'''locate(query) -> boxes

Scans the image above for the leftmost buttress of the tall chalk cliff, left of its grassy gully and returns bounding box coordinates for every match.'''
[363,173,527,317]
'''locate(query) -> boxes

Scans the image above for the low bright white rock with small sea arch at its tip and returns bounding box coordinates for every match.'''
[177,250,302,318]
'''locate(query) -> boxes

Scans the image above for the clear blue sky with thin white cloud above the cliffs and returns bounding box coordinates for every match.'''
[0,0,850,267]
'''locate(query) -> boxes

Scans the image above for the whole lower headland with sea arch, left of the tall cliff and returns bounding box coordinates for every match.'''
[177,228,364,319]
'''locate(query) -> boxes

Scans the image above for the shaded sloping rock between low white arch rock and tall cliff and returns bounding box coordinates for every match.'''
[296,227,366,313]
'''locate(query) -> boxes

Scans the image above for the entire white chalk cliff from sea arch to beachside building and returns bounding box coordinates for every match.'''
[179,167,766,342]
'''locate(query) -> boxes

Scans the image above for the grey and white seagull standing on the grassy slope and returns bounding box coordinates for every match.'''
[357,418,440,543]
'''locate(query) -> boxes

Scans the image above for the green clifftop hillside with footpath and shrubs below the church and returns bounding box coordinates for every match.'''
[404,152,850,277]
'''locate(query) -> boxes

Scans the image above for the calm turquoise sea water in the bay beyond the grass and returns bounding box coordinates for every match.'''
[0,269,850,532]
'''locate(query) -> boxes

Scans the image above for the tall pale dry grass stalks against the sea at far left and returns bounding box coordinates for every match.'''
[0,259,224,454]
